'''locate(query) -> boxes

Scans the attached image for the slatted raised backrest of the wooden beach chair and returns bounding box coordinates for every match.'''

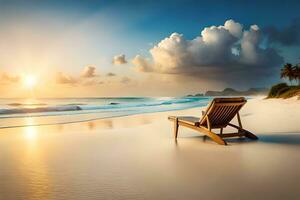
[200,97,247,128]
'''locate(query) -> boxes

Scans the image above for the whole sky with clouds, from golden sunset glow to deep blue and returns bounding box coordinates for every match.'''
[0,0,300,98]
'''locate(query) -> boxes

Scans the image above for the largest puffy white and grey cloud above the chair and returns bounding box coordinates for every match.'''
[132,20,283,86]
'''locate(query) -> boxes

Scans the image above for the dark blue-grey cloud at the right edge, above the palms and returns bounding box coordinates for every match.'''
[264,18,300,46]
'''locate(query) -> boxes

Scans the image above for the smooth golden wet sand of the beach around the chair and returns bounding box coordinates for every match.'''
[0,99,300,200]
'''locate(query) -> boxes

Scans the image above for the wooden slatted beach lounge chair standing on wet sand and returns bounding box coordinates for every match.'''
[168,97,258,145]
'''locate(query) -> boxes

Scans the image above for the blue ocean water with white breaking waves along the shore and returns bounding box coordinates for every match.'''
[0,97,212,129]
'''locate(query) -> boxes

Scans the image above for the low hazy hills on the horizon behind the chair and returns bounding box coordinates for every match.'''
[187,88,269,97]
